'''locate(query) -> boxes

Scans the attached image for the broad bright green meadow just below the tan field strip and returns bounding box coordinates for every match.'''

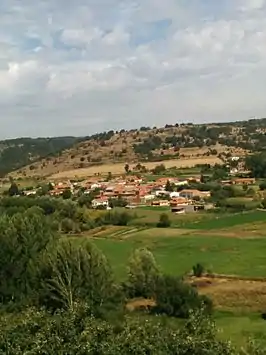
[85,235,266,278]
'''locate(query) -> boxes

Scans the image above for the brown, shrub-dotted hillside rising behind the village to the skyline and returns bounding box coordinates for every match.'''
[5,119,266,177]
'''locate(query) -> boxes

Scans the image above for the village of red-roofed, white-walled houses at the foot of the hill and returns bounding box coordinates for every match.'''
[23,174,256,214]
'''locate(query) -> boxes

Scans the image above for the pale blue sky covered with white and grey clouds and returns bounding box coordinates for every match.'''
[0,0,266,139]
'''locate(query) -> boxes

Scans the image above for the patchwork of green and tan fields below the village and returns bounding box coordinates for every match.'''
[68,209,266,345]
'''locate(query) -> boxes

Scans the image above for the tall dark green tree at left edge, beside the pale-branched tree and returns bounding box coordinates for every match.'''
[0,211,55,303]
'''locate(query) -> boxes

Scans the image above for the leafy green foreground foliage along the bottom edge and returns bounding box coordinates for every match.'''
[0,305,236,355]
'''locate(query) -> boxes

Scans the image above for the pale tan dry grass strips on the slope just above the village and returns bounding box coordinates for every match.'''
[50,157,221,179]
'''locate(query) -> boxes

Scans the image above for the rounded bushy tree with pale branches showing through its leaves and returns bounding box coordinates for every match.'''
[40,241,115,310]
